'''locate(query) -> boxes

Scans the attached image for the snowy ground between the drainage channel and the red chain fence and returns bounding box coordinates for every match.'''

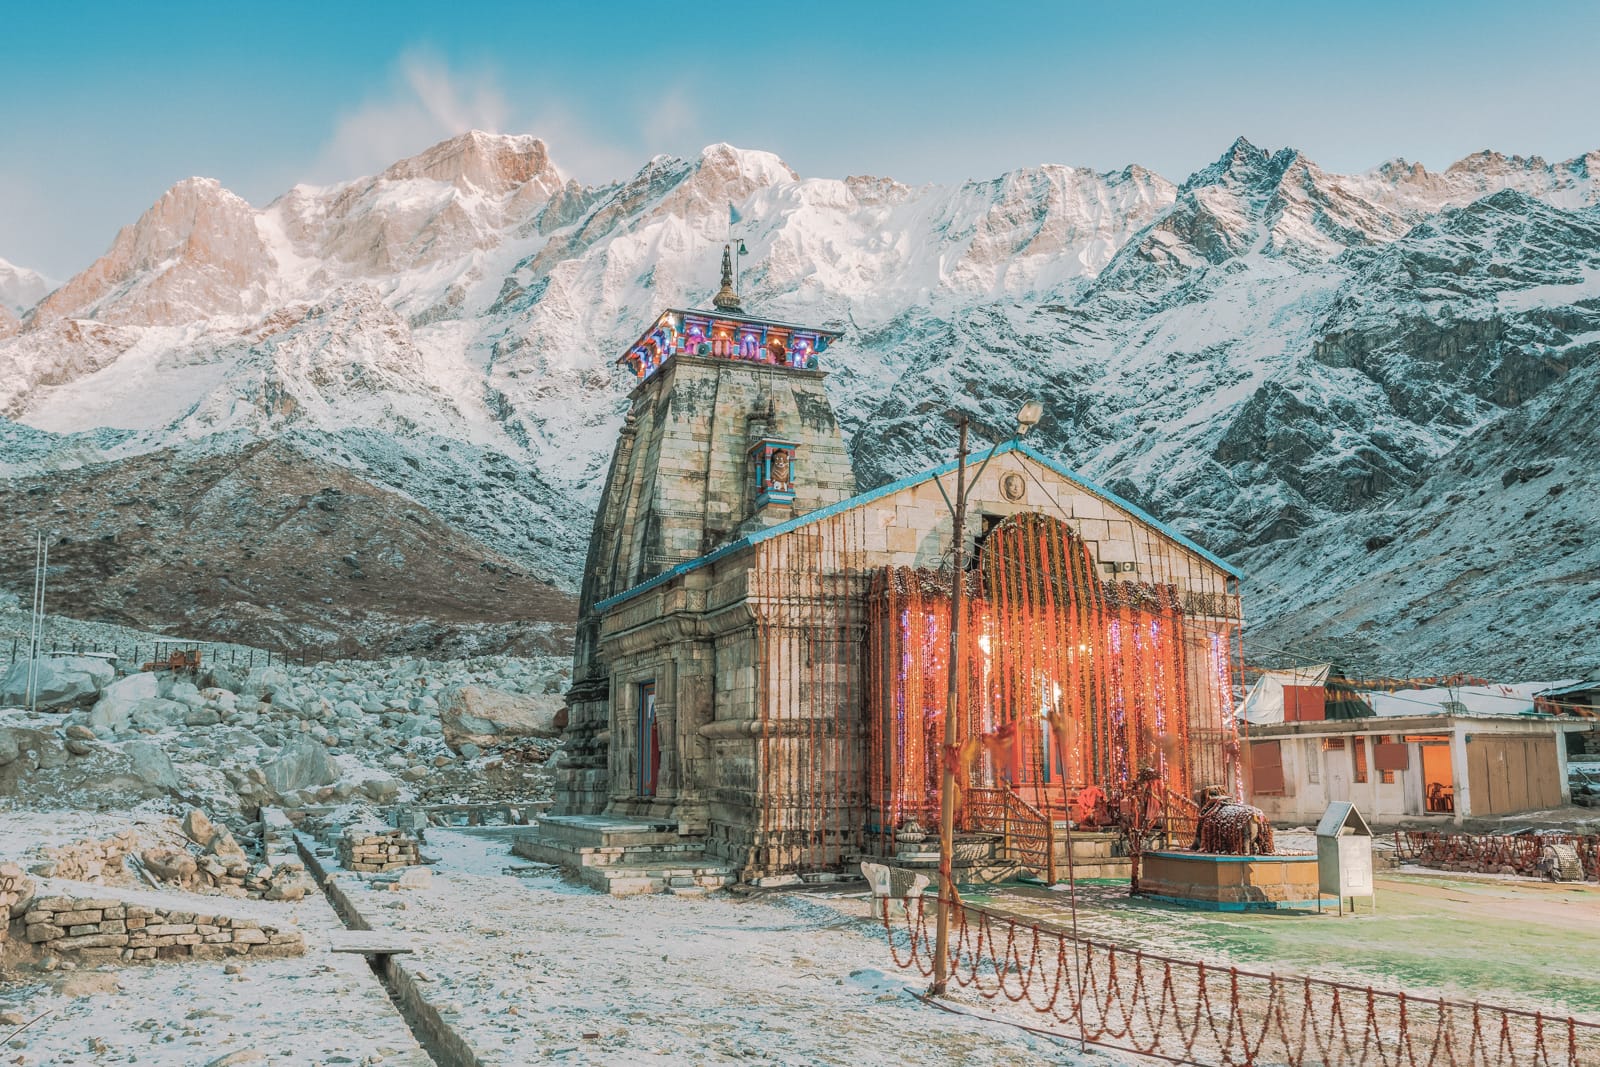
[323,830,1122,1067]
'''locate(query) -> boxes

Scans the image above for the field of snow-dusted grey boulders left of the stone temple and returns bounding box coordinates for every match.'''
[0,656,566,827]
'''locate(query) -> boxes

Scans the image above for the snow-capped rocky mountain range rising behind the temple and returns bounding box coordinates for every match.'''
[0,133,1600,673]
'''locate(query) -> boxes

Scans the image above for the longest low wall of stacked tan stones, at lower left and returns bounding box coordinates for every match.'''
[21,896,306,961]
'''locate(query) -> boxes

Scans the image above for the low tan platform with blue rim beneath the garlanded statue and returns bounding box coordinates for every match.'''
[1139,851,1322,912]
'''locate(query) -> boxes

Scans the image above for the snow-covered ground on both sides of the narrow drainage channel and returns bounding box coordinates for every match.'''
[0,813,1123,1067]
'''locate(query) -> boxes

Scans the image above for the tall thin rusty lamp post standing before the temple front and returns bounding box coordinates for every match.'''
[928,400,1045,997]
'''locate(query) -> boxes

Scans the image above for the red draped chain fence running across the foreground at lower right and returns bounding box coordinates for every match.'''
[882,899,1600,1067]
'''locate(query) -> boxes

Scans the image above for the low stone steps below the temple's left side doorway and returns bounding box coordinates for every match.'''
[510,816,734,896]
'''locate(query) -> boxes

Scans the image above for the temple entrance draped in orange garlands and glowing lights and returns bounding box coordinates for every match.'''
[870,514,1237,830]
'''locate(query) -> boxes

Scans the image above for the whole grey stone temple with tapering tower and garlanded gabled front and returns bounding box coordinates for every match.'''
[531,251,1240,893]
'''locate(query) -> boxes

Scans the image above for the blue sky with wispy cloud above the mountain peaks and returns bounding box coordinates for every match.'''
[0,0,1600,278]
